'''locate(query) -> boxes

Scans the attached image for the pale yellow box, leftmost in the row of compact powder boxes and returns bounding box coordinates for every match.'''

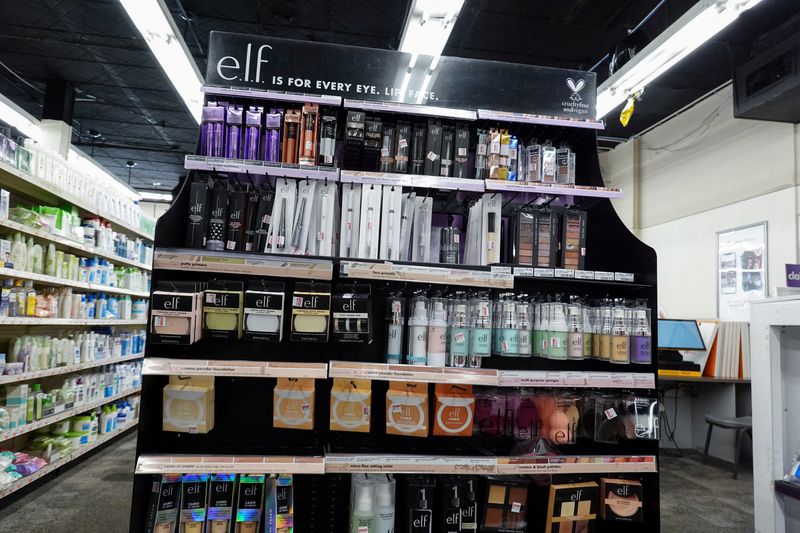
[161,376,215,434]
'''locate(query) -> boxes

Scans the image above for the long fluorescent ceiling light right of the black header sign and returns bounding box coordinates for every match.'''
[597,0,761,120]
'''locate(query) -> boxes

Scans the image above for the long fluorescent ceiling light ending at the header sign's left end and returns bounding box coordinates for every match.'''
[119,0,203,124]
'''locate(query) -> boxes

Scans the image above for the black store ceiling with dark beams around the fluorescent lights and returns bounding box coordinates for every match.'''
[0,0,800,190]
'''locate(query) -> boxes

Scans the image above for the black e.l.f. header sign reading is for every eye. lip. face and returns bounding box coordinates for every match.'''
[206,31,596,120]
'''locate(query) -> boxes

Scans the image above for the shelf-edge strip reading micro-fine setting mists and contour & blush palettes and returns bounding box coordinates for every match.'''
[325,454,657,475]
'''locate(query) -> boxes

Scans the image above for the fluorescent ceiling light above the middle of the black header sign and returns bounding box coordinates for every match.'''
[400,0,464,57]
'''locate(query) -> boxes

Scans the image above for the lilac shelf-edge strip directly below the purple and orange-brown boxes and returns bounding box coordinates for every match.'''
[184,155,339,181]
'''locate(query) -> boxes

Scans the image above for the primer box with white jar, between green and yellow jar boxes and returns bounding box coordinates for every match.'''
[244,279,285,342]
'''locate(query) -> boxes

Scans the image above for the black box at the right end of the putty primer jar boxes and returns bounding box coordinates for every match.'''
[331,284,372,344]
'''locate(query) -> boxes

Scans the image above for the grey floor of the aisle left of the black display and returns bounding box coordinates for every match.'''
[0,431,136,533]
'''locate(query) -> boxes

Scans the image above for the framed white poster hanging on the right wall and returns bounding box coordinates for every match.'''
[717,221,768,322]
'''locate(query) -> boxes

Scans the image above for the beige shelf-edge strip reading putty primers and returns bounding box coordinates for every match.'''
[153,248,333,280]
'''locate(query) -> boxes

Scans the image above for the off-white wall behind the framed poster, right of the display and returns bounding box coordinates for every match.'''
[600,82,800,318]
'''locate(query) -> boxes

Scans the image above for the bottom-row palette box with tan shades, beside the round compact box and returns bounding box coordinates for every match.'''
[546,481,599,533]
